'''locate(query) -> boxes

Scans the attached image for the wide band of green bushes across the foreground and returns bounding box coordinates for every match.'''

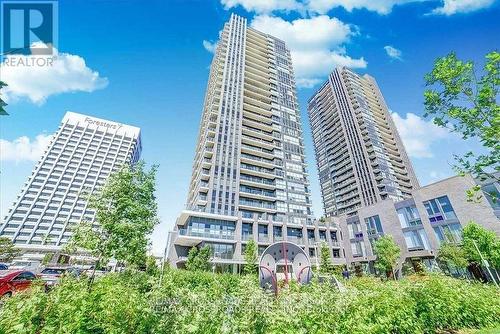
[0,269,500,334]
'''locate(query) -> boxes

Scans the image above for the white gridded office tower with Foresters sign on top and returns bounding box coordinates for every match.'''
[0,112,141,253]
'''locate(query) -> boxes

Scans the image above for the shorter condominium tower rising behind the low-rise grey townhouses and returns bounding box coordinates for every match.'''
[308,68,419,216]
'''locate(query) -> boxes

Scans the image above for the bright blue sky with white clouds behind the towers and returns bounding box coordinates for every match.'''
[0,0,500,253]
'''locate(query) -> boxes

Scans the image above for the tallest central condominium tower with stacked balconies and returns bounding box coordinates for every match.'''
[169,15,344,272]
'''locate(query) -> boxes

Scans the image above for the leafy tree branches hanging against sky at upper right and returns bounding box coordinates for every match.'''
[424,51,500,188]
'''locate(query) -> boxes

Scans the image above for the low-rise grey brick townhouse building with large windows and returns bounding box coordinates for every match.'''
[329,176,500,273]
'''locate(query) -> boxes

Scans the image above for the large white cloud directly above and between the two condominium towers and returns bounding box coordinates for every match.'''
[251,15,367,87]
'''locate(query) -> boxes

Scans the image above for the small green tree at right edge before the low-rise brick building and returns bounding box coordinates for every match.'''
[462,222,500,269]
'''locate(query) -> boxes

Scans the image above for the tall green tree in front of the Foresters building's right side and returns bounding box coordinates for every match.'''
[68,162,159,284]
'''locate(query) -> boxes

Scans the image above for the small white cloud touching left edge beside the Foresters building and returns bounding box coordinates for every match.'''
[0,134,52,162]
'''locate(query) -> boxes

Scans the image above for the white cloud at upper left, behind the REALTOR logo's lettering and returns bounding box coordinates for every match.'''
[0,42,108,104]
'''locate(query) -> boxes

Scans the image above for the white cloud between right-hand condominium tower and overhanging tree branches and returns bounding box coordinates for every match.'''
[391,112,456,158]
